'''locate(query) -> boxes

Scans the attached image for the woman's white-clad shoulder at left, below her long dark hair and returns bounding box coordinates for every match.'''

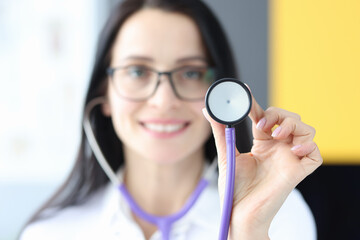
[20,187,108,240]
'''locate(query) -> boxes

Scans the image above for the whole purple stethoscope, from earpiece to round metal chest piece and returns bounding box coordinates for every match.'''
[83,78,252,240]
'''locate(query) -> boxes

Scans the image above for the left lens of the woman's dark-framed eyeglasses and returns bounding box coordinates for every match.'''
[112,66,157,100]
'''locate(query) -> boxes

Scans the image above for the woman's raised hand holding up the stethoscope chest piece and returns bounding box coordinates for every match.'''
[204,89,322,239]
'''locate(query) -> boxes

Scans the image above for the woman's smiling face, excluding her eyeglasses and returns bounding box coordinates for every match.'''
[104,9,210,164]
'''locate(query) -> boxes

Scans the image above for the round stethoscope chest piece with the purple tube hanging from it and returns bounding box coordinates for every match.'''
[205,78,252,240]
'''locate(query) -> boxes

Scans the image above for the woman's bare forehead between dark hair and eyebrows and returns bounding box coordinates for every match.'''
[112,9,205,64]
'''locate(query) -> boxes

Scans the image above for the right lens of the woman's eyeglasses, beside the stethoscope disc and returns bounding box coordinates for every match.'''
[173,67,214,100]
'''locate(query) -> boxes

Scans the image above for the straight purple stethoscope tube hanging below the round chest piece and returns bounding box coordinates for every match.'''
[219,127,235,240]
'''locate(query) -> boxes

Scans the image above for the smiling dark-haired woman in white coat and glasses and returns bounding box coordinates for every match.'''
[21,0,322,240]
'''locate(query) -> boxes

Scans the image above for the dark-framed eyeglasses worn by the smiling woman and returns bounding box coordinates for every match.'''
[107,65,214,101]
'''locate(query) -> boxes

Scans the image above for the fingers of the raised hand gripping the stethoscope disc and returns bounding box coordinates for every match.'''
[203,84,323,174]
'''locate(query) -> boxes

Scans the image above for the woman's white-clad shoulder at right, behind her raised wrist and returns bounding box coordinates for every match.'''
[269,189,316,240]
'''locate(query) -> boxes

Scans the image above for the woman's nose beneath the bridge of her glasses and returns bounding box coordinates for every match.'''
[148,74,181,110]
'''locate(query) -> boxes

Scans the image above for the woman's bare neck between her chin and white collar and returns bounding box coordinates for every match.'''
[125,148,204,216]
